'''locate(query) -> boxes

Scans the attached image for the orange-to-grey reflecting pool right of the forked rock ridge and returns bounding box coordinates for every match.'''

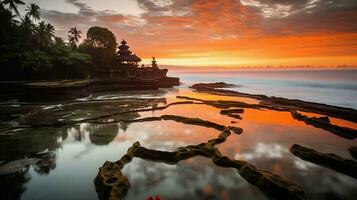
[219,109,357,199]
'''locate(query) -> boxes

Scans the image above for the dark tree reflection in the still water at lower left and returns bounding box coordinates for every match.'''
[0,129,67,199]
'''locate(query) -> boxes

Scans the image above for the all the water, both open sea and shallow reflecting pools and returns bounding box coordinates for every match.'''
[0,70,357,200]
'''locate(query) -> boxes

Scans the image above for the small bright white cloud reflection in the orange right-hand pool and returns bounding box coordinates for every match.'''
[234,143,289,160]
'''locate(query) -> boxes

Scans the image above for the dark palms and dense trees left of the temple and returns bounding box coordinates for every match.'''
[0,0,116,81]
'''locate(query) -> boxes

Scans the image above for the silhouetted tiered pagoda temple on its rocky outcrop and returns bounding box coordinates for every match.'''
[93,39,180,88]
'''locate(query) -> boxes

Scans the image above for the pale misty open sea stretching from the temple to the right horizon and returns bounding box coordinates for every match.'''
[171,69,357,109]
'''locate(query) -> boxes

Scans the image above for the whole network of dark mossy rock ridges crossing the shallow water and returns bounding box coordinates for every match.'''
[0,83,357,199]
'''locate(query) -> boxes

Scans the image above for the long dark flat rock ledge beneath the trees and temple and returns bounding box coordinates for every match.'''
[0,77,180,101]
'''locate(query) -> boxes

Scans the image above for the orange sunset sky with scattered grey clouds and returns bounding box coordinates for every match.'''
[21,0,357,67]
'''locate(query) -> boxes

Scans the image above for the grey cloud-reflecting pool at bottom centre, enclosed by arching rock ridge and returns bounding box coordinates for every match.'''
[123,157,265,200]
